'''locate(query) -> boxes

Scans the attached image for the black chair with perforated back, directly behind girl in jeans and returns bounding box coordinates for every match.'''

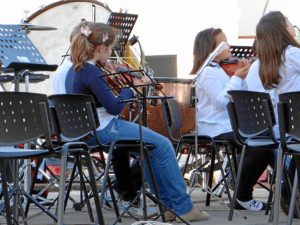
[49,95,106,225]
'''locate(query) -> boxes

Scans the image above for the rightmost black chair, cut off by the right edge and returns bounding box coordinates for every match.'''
[273,92,300,225]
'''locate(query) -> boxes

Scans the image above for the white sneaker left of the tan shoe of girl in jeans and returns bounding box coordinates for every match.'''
[118,200,158,219]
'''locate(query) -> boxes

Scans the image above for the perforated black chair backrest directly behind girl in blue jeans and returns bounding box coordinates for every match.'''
[48,94,99,141]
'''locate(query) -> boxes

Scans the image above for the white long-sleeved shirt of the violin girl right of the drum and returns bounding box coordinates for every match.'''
[196,63,247,137]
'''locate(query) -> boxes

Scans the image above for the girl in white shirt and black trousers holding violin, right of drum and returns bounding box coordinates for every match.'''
[191,28,273,211]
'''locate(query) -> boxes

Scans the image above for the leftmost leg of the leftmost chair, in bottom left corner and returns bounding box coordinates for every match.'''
[0,159,13,225]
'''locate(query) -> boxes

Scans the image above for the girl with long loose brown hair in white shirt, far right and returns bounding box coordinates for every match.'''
[246,11,300,216]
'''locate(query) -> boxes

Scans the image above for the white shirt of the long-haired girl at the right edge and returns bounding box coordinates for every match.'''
[245,45,300,136]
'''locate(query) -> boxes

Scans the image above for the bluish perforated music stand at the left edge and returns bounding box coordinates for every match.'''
[0,24,57,91]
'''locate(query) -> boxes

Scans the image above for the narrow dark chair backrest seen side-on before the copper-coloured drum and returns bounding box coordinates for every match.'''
[162,99,183,141]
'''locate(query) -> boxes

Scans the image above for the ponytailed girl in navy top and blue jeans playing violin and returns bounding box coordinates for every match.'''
[66,20,208,221]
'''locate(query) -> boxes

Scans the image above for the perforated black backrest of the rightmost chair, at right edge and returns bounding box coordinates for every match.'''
[278,92,300,141]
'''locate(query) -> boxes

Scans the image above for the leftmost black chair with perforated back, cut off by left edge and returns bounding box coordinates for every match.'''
[0,92,57,225]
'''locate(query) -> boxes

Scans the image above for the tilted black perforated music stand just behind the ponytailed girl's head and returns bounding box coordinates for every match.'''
[107,12,138,56]
